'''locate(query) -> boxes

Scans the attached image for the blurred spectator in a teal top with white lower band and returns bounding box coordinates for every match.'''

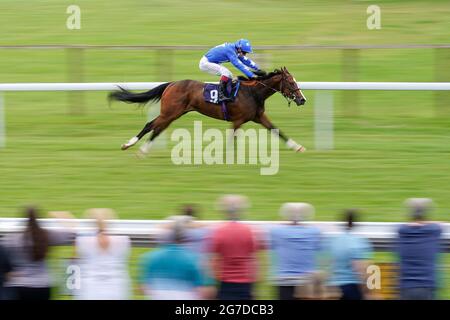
[139,217,204,300]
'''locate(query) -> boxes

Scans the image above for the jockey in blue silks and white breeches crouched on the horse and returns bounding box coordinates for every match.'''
[199,39,266,101]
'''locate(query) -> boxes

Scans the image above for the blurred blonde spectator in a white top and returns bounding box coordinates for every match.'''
[75,208,132,300]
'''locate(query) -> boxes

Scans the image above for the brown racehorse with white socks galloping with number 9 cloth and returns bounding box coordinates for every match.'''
[109,67,306,155]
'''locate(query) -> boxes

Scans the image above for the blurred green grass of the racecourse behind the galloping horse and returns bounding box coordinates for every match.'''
[0,0,450,298]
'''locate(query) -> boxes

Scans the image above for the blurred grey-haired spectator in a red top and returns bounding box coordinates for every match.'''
[209,195,261,300]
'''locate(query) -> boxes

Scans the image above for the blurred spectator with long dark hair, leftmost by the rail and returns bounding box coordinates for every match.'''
[4,207,74,300]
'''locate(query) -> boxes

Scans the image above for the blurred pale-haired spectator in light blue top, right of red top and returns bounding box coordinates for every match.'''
[269,203,321,300]
